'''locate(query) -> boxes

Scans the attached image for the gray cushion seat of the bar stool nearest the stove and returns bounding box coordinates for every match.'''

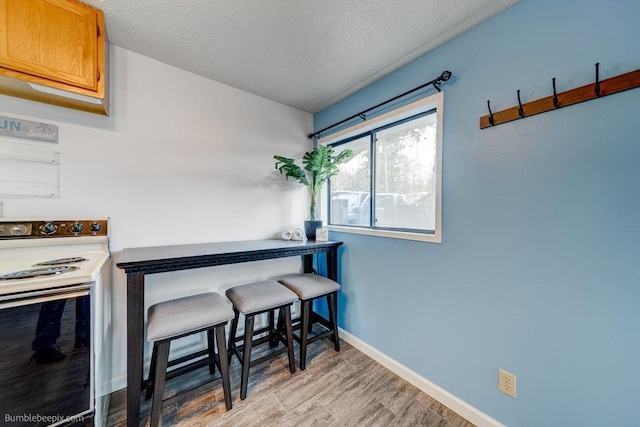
[147,292,234,342]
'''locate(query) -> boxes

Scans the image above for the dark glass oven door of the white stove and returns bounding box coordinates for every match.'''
[0,283,93,426]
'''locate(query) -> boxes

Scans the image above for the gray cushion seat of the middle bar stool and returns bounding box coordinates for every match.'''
[227,280,298,314]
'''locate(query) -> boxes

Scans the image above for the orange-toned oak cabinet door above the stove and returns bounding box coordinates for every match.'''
[0,0,99,91]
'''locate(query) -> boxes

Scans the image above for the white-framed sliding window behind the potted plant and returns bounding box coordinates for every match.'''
[320,93,442,242]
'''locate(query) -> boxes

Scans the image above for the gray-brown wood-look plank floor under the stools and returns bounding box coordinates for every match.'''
[107,334,473,427]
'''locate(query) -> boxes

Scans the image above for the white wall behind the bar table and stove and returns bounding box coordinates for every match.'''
[0,46,312,388]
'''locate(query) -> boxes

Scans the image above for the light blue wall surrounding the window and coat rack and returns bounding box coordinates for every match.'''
[314,0,640,426]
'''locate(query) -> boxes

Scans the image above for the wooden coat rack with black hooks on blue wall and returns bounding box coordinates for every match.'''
[480,63,640,129]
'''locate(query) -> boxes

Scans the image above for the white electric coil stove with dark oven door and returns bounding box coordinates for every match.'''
[0,219,112,426]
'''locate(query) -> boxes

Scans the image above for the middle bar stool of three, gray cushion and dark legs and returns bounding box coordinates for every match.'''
[227,280,298,400]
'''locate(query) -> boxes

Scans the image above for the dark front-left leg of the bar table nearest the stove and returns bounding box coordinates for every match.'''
[127,273,144,427]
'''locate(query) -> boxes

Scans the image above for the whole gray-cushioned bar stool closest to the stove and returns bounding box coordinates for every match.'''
[146,292,233,427]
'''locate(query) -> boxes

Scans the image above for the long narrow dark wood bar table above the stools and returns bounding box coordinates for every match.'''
[116,239,342,427]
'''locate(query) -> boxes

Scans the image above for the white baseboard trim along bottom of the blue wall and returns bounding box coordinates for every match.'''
[339,329,505,427]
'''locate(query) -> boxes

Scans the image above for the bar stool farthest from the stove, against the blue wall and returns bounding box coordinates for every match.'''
[277,273,340,371]
